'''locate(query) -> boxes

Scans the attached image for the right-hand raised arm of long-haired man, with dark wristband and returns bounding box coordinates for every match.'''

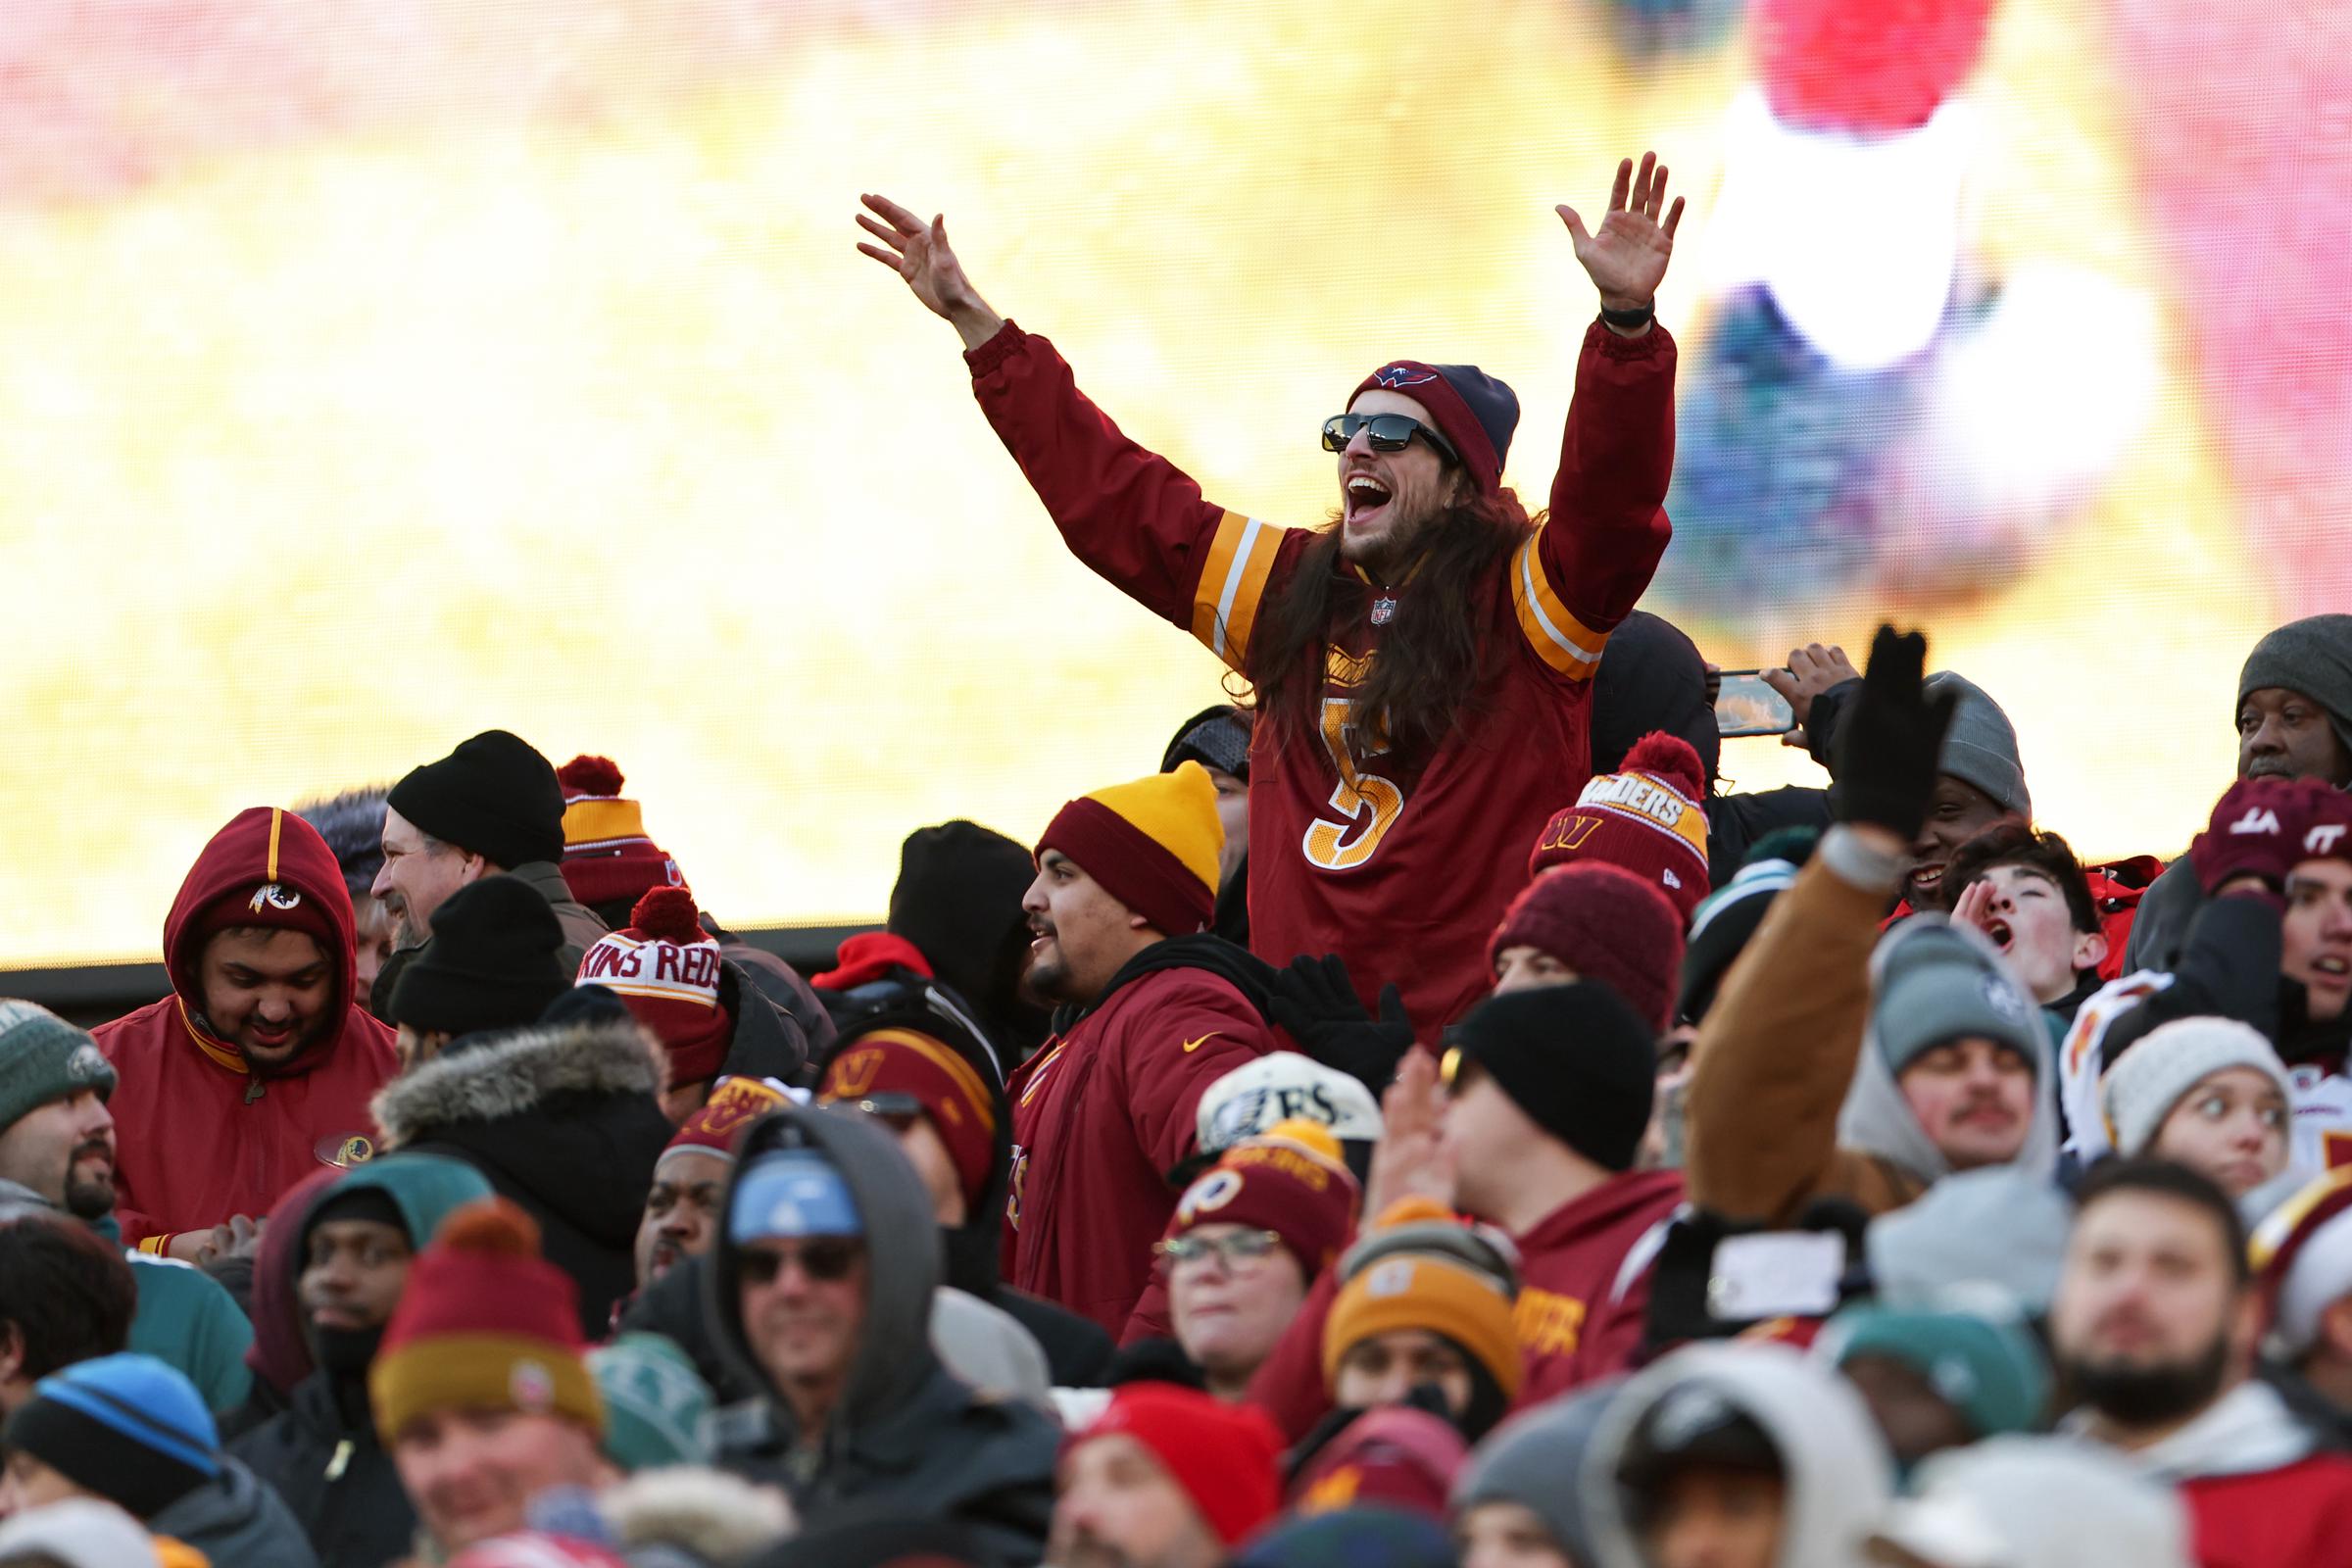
[1512,153,1682,679]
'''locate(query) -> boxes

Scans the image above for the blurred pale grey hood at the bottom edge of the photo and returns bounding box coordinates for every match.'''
[1583,1343,1893,1568]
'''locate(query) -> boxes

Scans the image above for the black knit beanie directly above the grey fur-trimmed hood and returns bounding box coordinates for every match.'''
[390,877,571,1034]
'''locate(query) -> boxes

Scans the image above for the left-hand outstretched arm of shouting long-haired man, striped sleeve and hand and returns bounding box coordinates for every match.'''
[858,195,1287,670]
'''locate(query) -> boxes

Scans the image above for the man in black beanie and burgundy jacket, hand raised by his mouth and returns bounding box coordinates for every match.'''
[1249,980,1682,1439]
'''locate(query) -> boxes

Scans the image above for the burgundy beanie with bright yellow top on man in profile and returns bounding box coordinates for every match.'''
[1037,761,1225,936]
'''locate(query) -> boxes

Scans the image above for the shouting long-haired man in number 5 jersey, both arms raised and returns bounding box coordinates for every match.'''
[858,158,1682,1039]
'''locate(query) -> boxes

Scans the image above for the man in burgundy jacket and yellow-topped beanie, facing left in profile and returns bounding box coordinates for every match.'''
[1004,761,1275,1340]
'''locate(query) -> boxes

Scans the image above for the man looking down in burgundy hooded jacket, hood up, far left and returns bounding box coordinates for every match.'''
[92,807,395,1262]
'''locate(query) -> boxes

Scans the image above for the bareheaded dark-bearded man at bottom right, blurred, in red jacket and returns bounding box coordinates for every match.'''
[2051,1159,2352,1568]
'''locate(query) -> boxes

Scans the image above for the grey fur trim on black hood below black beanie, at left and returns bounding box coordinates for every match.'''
[371,1018,663,1150]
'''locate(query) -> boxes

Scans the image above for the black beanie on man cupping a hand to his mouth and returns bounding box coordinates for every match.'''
[1446,980,1658,1171]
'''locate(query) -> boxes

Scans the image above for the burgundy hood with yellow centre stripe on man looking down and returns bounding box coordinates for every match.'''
[163,807,360,1077]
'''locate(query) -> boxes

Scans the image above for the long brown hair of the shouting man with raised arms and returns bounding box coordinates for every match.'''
[1245,489,1541,764]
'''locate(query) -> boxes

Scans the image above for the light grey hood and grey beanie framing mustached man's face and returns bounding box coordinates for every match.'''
[1837,914,2058,1183]
